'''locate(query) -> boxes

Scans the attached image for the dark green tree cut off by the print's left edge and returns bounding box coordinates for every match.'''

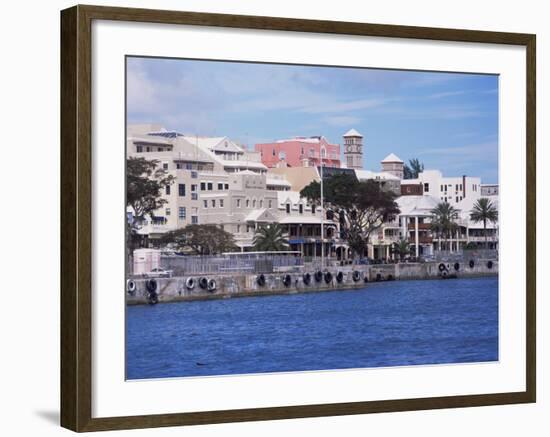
[126,157,174,222]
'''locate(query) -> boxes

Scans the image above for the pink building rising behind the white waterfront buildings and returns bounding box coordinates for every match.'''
[255,136,340,168]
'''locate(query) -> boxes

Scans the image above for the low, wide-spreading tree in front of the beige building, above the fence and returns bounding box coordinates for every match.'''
[159,224,238,255]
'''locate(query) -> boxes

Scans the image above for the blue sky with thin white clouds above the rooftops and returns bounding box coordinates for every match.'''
[127,58,498,183]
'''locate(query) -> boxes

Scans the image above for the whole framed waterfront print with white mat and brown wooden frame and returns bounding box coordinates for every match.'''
[61,6,536,431]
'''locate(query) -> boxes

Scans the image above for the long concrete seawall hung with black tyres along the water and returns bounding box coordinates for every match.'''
[126,260,498,305]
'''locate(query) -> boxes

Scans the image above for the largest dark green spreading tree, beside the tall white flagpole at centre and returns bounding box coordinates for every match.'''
[300,174,399,257]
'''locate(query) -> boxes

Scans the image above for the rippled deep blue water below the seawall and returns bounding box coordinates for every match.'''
[126,277,498,379]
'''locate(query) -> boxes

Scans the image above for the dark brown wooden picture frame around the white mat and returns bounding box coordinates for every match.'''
[61,6,536,432]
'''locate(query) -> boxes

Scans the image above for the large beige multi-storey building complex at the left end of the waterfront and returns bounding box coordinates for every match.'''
[127,125,322,250]
